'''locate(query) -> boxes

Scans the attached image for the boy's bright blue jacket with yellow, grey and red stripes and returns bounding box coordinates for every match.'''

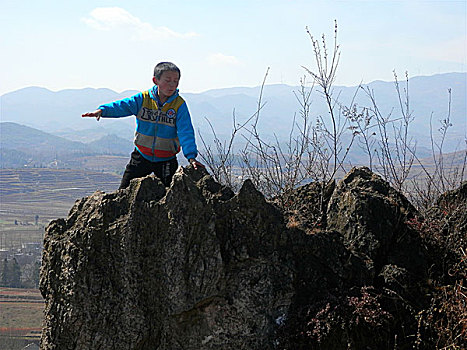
[98,86,198,162]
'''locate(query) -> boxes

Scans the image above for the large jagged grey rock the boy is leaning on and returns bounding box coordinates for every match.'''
[41,167,293,350]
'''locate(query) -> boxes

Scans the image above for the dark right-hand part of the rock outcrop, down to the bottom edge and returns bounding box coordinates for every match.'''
[280,167,428,350]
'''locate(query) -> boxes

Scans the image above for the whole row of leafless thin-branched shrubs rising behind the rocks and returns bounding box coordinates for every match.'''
[200,23,467,216]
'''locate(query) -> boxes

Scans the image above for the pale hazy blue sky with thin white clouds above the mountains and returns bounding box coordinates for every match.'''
[0,0,467,94]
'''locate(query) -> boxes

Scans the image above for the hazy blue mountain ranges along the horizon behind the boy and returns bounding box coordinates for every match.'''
[1,73,467,170]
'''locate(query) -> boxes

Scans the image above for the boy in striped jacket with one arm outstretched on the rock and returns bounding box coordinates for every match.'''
[82,62,204,189]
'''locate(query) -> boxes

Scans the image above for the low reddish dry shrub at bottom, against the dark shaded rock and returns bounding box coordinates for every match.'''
[279,287,393,349]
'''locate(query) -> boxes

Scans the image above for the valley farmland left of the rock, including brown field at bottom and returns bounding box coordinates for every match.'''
[0,168,120,350]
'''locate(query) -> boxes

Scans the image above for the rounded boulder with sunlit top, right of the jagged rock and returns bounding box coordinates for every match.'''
[327,168,427,297]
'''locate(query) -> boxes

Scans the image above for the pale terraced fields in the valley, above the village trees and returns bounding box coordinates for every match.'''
[0,168,121,249]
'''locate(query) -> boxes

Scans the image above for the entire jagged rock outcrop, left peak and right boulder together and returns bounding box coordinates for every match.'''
[41,167,438,350]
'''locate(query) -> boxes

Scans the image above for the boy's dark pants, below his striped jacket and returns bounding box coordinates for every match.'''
[119,149,178,189]
